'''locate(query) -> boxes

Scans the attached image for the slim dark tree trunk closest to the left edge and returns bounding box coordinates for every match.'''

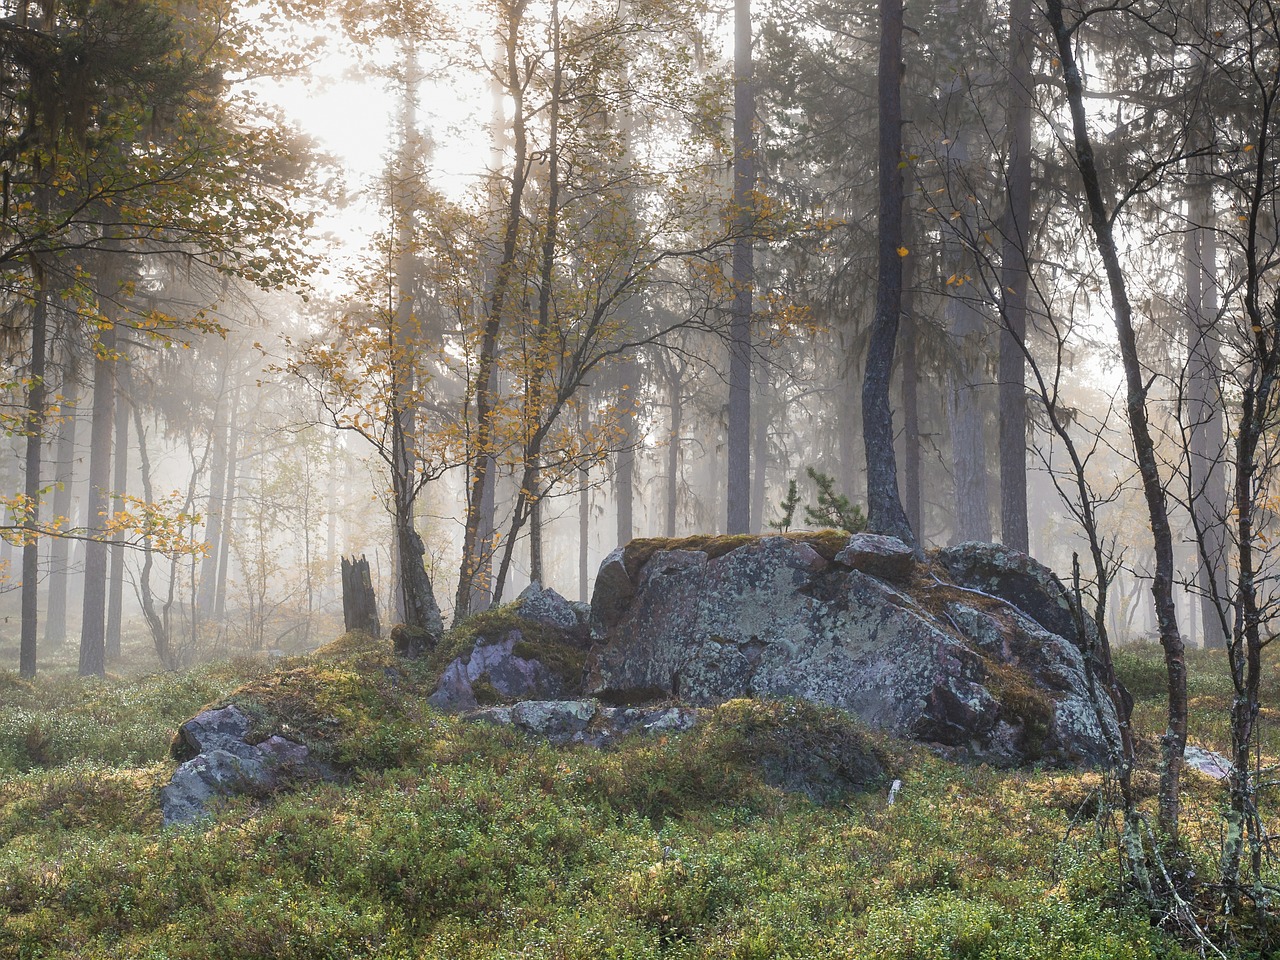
[18,262,49,680]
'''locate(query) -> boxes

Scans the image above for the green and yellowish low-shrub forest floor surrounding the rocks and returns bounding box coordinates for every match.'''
[0,627,1280,960]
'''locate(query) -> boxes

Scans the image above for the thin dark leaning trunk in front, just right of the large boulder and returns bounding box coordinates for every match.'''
[1047,0,1188,847]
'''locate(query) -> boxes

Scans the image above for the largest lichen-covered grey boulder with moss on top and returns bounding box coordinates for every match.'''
[586,536,1116,764]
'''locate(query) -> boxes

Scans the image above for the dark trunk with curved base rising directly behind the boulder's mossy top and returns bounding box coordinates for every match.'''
[863,0,915,547]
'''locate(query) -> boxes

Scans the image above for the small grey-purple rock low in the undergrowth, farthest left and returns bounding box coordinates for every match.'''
[160,707,310,827]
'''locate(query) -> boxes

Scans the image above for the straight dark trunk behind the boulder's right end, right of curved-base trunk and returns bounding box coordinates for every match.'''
[998,0,1033,553]
